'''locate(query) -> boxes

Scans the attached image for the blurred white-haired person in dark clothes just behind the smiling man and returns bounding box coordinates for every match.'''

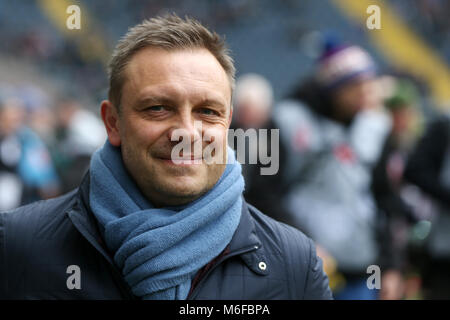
[229,73,286,219]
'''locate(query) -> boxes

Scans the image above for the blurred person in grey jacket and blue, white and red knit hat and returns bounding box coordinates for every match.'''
[274,42,395,299]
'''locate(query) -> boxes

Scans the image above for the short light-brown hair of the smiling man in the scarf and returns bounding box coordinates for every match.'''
[108,14,236,110]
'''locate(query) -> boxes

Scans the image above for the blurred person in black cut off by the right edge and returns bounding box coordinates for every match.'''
[405,113,450,299]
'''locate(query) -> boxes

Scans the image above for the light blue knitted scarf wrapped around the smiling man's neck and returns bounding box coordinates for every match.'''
[90,141,244,300]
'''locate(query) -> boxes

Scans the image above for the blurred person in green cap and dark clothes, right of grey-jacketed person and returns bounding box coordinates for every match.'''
[372,76,420,299]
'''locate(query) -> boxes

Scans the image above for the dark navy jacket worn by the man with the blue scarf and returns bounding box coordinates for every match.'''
[0,175,332,300]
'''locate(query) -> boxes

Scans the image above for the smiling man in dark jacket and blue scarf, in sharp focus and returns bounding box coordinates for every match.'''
[0,15,331,300]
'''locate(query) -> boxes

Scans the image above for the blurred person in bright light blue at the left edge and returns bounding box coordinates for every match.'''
[0,90,59,210]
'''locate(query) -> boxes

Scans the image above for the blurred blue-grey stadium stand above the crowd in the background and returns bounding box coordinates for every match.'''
[0,0,450,110]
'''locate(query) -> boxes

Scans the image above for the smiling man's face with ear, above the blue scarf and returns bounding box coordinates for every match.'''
[102,48,231,206]
